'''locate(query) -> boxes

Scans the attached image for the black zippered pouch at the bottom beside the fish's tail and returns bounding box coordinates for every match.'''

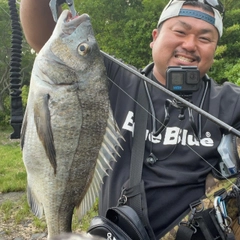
[88,205,150,240]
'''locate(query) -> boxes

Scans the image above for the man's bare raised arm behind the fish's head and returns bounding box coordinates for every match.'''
[20,0,59,52]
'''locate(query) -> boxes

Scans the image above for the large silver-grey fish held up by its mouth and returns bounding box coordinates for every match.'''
[21,10,121,239]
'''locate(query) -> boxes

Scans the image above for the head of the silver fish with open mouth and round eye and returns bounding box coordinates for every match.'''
[38,10,105,84]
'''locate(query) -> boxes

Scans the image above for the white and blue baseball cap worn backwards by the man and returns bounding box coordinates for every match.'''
[157,0,223,37]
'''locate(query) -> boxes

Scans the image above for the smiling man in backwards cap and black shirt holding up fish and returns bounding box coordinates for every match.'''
[20,0,240,239]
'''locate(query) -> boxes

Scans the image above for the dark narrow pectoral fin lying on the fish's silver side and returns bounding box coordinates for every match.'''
[34,94,57,174]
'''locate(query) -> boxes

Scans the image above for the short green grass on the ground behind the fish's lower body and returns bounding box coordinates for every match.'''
[0,127,97,234]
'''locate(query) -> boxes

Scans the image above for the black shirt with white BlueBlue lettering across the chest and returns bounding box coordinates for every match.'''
[99,55,240,238]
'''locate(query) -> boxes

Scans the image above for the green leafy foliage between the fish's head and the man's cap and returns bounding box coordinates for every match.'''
[75,0,168,68]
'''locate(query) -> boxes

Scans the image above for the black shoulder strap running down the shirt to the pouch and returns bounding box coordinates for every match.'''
[126,81,155,239]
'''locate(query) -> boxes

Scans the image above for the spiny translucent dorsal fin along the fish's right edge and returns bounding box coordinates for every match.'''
[76,111,125,219]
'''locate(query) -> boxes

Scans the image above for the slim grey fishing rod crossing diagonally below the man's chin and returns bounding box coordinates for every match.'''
[101,51,240,137]
